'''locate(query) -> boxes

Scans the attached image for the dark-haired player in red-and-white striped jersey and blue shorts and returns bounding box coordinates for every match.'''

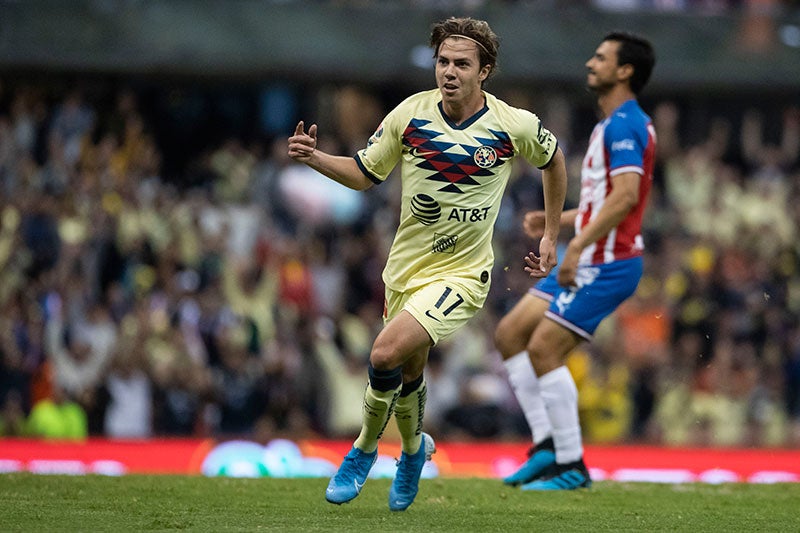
[495,33,656,490]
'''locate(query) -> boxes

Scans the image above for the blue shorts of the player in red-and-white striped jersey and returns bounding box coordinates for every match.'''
[529,257,644,340]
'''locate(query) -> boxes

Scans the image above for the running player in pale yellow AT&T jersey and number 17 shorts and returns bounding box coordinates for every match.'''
[289,18,567,511]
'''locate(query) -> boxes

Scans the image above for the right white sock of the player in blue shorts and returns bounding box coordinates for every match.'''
[539,366,583,464]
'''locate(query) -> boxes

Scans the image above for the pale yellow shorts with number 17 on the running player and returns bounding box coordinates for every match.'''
[383,279,487,344]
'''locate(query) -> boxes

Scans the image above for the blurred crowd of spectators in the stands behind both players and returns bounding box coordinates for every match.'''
[0,69,800,447]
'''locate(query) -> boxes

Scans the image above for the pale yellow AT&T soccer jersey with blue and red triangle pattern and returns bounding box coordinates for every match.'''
[355,89,558,292]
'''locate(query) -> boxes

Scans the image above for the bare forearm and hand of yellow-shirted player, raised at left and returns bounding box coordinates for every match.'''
[289,120,373,191]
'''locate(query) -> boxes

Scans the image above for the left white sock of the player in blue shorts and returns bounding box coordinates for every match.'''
[503,350,553,444]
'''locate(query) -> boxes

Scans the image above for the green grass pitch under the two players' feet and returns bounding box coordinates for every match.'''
[0,474,800,533]
